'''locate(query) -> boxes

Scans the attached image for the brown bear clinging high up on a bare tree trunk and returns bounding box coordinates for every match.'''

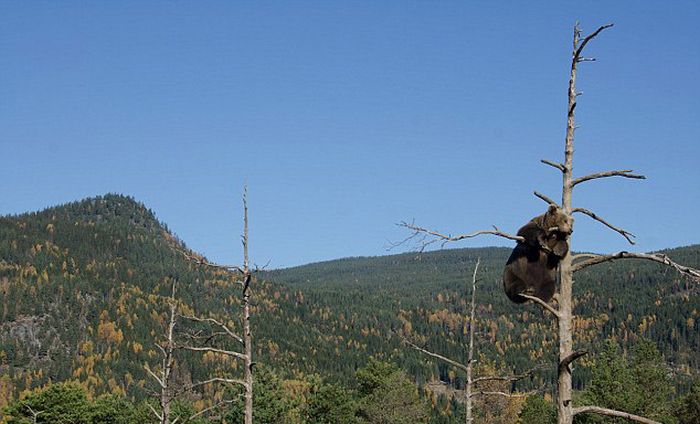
[503,205,573,303]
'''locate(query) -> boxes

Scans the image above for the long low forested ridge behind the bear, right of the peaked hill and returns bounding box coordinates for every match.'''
[266,245,700,385]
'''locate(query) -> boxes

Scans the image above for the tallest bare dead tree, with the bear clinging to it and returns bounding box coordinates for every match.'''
[399,23,700,424]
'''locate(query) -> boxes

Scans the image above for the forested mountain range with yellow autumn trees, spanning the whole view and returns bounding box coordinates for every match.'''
[0,194,700,406]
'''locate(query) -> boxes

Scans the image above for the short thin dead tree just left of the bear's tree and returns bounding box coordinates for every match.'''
[403,259,535,424]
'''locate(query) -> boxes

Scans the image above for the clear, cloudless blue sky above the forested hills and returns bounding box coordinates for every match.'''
[0,1,700,267]
